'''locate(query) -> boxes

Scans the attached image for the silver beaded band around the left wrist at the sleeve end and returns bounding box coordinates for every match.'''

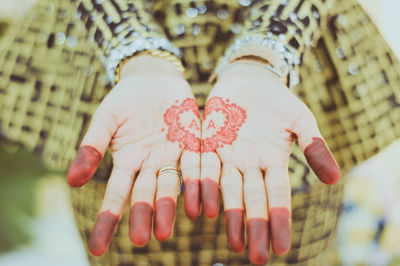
[100,37,181,85]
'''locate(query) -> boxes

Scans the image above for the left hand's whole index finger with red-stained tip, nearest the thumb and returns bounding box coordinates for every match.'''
[89,167,134,256]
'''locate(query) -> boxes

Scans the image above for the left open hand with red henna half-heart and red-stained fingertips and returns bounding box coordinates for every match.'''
[68,55,200,256]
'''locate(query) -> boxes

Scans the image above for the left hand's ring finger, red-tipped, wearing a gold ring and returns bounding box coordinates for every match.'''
[154,168,180,241]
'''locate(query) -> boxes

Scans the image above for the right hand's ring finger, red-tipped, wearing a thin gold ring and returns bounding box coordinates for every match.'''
[221,166,245,253]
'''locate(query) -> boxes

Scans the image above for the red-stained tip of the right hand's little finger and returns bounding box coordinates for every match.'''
[201,177,219,219]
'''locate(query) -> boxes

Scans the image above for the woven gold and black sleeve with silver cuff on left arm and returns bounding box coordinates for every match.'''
[71,0,180,83]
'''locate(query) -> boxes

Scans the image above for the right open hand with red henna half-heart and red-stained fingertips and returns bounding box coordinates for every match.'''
[201,61,340,264]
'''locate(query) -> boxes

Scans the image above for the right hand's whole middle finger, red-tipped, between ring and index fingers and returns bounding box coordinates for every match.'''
[243,168,270,264]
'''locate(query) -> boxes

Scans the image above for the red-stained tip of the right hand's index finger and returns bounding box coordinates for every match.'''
[269,207,290,255]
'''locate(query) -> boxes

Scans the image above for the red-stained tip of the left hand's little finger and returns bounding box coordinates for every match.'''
[184,179,201,220]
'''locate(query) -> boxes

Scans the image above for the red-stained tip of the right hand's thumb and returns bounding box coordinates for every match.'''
[304,138,340,185]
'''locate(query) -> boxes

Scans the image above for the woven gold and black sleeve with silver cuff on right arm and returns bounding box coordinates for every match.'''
[216,0,332,87]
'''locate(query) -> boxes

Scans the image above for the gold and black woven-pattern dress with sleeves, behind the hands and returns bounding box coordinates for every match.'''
[0,0,400,265]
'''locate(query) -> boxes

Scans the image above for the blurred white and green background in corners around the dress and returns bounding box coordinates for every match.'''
[0,0,400,266]
